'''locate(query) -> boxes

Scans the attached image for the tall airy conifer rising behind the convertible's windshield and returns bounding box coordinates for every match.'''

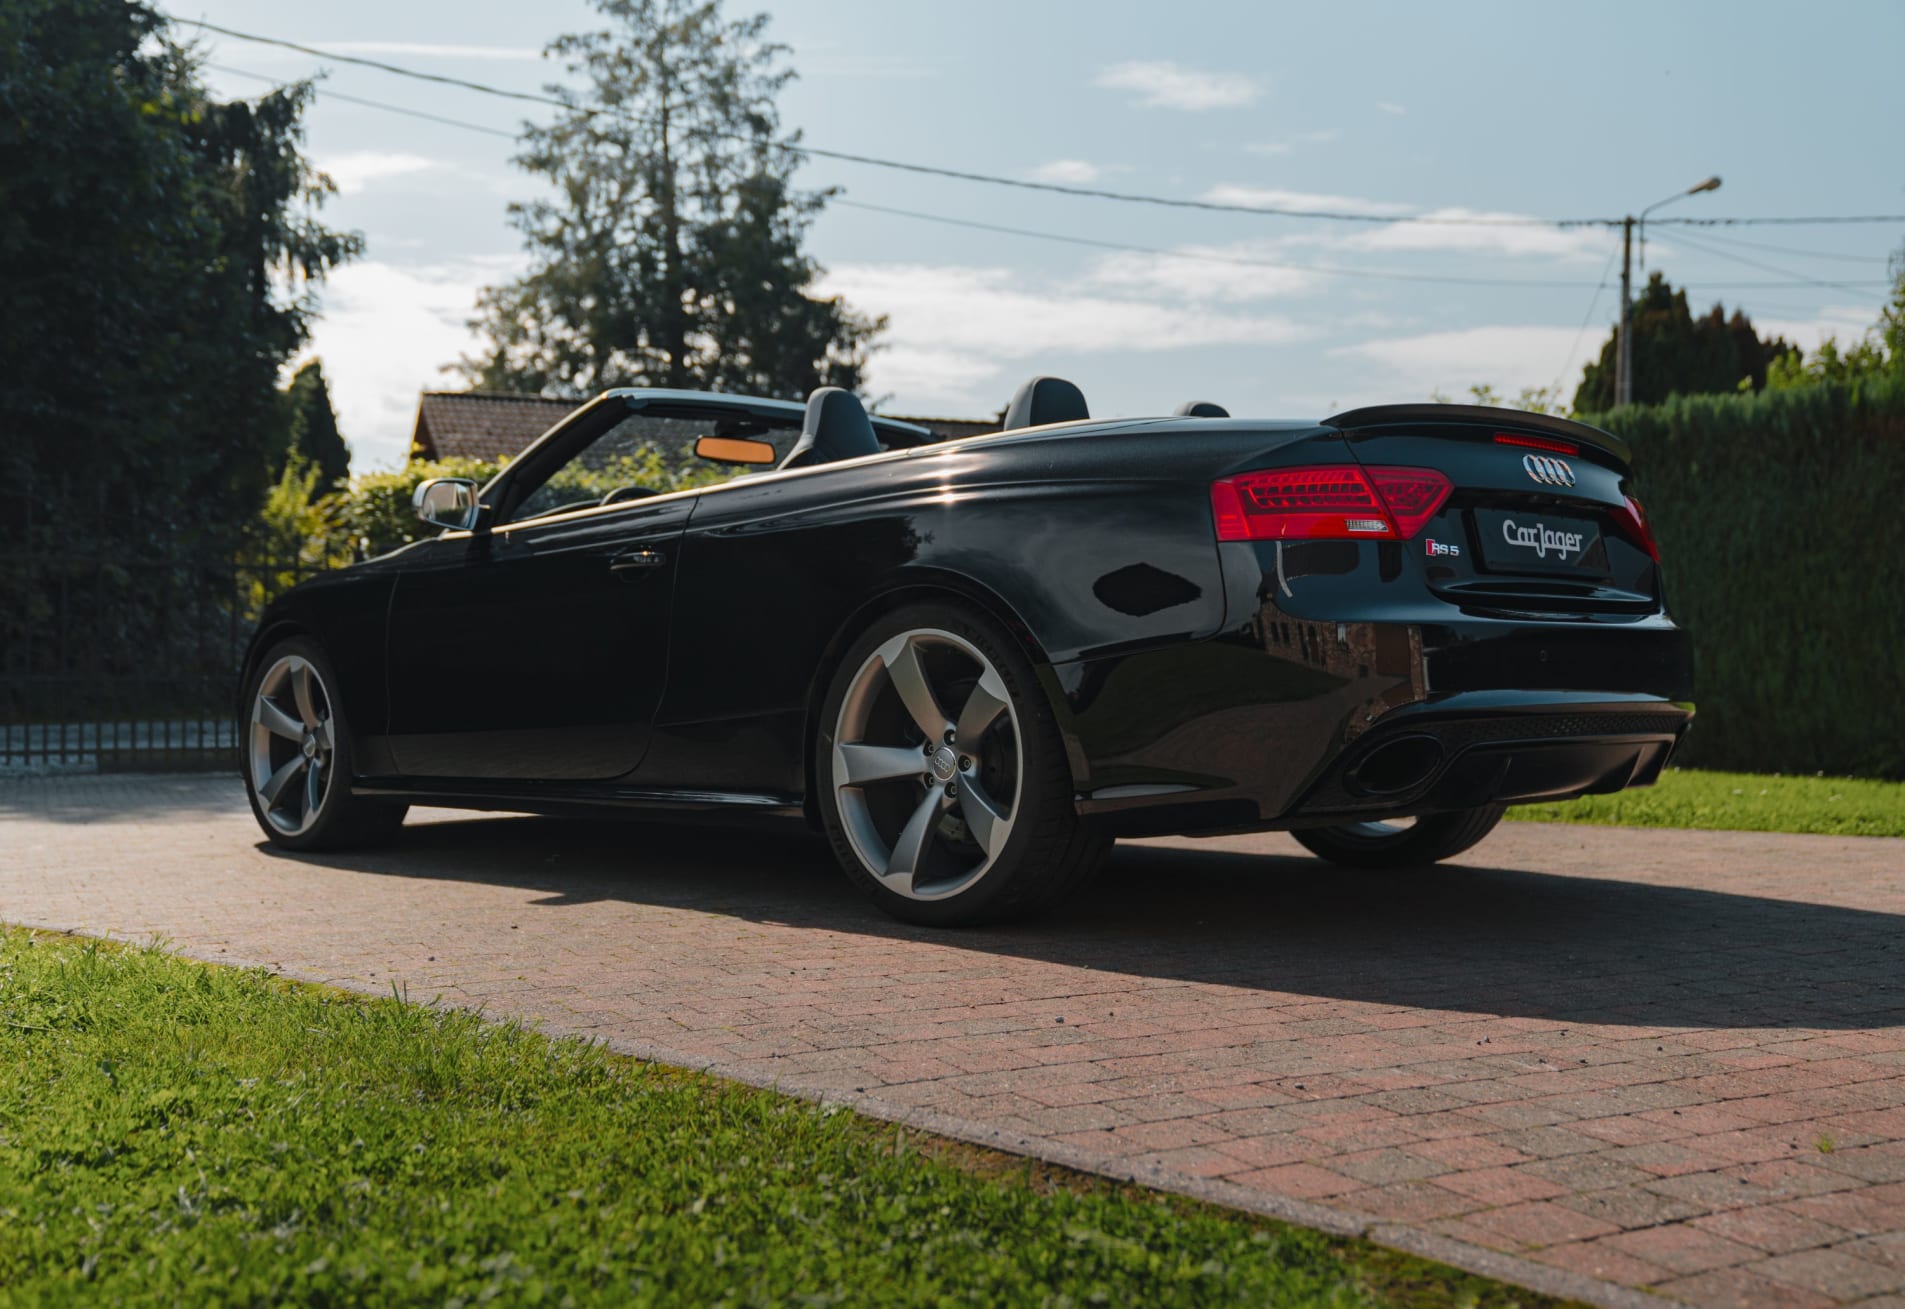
[461,0,884,398]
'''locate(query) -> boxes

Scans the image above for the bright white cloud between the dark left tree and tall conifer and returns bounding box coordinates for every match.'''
[311,255,522,473]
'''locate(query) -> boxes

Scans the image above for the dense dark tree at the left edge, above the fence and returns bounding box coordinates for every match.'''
[0,0,360,554]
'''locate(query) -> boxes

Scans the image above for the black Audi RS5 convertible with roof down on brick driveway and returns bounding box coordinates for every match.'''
[240,377,1692,924]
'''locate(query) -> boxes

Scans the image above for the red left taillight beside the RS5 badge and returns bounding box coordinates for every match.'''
[1210,465,1450,541]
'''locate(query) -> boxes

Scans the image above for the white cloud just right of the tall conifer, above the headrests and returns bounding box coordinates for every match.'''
[823,263,1309,413]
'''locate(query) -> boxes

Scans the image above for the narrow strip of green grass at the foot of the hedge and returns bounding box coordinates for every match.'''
[1509,768,1905,836]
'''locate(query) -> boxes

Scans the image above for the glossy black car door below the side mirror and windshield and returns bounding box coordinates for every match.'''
[387,493,695,781]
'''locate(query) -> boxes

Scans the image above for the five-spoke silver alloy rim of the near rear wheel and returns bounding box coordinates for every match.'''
[832,627,1025,899]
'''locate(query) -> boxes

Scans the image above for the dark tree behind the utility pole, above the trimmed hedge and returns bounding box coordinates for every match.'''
[1574,272,1793,412]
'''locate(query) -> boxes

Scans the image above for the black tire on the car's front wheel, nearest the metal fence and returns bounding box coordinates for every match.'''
[238,636,410,850]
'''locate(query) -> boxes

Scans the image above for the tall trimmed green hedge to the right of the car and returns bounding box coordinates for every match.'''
[1581,375,1905,777]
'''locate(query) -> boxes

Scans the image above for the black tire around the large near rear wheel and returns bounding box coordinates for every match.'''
[813,602,1113,926]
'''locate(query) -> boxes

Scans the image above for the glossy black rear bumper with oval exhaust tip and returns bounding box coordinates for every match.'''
[1048,606,1692,836]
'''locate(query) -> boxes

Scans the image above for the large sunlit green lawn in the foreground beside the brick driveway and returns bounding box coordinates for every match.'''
[0,930,1553,1307]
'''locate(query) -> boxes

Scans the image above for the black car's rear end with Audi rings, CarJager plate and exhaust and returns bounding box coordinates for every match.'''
[1210,406,1692,827]
